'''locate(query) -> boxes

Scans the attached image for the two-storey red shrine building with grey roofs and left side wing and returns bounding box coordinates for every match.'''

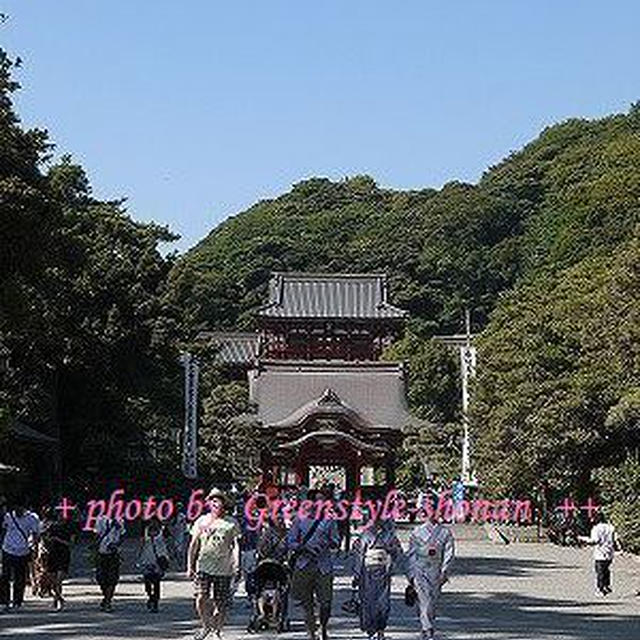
[202,272,409,492]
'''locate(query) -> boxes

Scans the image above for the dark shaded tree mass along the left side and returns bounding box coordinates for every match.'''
[0,52,180,498]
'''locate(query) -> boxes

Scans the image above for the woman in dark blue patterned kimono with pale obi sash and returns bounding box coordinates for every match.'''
[353,519,404,640]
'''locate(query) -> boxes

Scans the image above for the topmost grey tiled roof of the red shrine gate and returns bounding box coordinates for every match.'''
[258,272,407,319]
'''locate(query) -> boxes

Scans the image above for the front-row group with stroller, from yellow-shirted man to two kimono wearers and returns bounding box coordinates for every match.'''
[187,488,454,640]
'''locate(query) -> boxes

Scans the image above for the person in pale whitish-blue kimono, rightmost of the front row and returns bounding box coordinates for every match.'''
[407,516,455,640]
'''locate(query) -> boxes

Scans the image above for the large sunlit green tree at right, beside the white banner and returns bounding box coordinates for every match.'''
[474,239,640,494]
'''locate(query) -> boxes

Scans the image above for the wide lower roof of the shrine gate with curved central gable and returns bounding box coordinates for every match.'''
[249,360,411,429]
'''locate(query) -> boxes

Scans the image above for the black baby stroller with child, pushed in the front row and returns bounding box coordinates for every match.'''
[248,558,289,632]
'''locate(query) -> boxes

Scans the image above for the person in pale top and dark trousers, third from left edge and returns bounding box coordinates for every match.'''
[95,516,125,613]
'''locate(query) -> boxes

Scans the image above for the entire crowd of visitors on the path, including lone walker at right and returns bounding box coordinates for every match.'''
[0,483,628,640]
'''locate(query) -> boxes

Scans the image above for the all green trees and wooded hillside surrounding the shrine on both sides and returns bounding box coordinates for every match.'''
[0,38,640,539]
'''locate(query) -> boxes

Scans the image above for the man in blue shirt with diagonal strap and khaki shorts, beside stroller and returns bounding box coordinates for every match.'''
[287,490,340,640]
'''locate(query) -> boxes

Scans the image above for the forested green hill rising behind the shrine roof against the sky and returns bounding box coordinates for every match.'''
[172,106,640,335]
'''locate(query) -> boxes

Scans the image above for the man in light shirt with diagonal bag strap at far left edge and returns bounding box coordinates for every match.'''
[0,499,40,612]
